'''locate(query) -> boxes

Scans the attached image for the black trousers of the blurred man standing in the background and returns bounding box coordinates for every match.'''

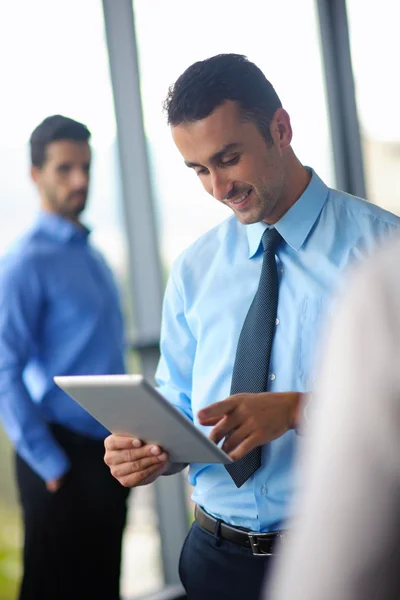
[16,425,129,600]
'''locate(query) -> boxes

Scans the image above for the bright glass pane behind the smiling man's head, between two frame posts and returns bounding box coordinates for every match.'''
[134,0,334,267]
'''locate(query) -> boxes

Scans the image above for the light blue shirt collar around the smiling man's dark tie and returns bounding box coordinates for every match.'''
[246,167,329,258]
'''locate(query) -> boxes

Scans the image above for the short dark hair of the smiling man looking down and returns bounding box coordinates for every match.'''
[164,54,282,144]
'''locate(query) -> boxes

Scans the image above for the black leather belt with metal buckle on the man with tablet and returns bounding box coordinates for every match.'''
[194,504,286,556]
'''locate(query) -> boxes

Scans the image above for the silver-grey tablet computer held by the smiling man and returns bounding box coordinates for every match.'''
[54,375,232,464]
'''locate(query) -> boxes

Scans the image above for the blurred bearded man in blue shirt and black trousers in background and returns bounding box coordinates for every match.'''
[0,115,127,600]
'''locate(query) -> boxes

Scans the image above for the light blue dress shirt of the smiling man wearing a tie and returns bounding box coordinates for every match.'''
[156,171,400,531]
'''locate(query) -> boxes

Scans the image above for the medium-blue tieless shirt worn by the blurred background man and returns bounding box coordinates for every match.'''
[0,212,124,480]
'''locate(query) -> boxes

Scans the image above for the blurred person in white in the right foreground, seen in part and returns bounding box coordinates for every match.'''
[265,234,400,600]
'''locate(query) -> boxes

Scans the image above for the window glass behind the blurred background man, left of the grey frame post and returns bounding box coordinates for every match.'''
[0,0,156,600]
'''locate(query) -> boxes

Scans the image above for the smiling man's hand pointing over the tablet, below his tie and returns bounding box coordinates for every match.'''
[198,392,301,460]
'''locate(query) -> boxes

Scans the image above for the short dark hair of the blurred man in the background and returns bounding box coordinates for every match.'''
[29,115,91,167]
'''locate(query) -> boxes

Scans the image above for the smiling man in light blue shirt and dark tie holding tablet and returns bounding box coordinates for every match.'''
[105,54,400,600]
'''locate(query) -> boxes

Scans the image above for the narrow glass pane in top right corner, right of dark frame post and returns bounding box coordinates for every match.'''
[347,0,400,214]
